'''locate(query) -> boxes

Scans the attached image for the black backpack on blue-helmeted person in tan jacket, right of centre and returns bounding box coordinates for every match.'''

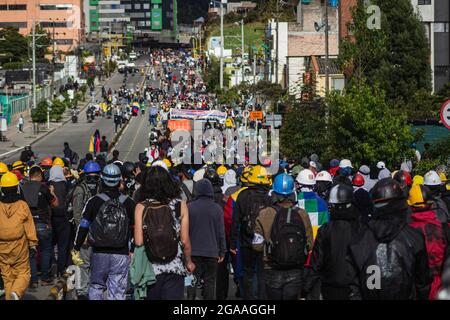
[267,206,308,269]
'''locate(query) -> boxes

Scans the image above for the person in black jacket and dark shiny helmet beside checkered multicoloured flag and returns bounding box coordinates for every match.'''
[304,184,361,300]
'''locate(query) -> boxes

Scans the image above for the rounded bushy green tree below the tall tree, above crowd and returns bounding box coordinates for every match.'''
[327,82,414,165]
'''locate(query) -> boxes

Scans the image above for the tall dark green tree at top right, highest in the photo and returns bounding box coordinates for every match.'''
[340,0,431,106]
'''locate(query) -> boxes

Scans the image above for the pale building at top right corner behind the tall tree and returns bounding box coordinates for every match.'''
[411,0,450,91]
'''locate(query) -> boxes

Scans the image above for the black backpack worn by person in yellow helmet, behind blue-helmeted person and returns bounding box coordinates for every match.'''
[242,189,272,238]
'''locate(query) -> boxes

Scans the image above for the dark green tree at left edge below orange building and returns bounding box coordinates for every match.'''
[0,27,28,63]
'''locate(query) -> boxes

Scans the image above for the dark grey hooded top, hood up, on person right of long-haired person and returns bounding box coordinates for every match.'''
[188,179,226,258]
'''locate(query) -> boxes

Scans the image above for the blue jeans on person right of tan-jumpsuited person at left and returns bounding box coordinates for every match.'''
[30,222,53,283]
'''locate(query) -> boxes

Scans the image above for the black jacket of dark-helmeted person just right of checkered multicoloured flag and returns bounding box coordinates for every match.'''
[305,206,361,299]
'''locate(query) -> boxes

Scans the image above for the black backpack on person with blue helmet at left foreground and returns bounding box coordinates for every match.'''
[89,193,129,248]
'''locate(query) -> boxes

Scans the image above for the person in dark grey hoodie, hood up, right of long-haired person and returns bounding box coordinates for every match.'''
[188,179,226,300]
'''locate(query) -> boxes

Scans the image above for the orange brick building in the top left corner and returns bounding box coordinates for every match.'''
[0,0,84,52]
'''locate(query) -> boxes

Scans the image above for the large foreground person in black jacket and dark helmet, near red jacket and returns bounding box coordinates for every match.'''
[347,178,433,300]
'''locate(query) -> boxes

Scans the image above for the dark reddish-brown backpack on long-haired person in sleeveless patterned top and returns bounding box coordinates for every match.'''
[142,201,181,264]
